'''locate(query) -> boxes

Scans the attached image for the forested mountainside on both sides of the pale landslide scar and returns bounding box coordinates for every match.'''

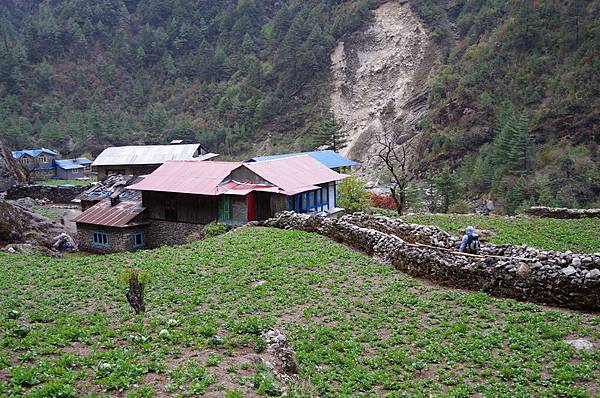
[0,0,600,208]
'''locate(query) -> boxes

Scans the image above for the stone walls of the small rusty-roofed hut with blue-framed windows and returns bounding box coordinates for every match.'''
[76,223,147,254]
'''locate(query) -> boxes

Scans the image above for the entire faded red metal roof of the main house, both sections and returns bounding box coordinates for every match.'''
[129,156,347,196]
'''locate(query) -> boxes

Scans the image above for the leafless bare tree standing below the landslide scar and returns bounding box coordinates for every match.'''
[376,133,414,215]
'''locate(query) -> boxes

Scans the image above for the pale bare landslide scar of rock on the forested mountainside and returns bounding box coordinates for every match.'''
[331,1,439,174]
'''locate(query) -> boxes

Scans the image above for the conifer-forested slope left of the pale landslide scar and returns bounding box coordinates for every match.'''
[0,0,375,155]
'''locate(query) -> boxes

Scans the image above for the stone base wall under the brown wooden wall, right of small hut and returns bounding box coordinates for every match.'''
[146,220,204,248]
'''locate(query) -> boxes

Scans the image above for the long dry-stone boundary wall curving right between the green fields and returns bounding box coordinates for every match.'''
[254,212,600,310]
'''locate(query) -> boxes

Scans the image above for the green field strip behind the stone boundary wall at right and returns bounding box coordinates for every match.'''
[402,214,600,253]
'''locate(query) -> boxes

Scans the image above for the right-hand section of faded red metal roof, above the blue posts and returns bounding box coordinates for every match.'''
[244,155,347,195]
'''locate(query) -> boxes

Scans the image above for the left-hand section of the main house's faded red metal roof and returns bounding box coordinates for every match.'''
[129,160,241,195]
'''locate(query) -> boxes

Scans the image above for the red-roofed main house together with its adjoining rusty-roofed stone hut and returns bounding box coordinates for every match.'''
[74,155,347,252]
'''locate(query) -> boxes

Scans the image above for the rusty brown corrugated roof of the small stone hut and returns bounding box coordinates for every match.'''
[73,199,146,228]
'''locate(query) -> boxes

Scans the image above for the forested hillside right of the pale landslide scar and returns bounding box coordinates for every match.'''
[411,0,600,213]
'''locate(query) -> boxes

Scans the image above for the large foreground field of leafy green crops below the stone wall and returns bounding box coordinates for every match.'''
[0,228,600,398]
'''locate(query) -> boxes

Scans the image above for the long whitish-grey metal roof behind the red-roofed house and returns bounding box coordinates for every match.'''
[92,144,205,166]
